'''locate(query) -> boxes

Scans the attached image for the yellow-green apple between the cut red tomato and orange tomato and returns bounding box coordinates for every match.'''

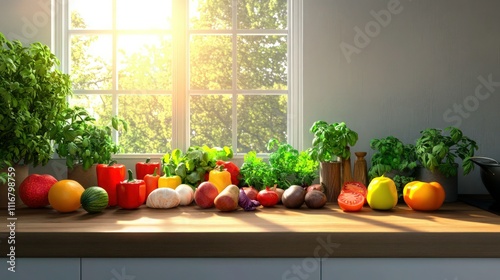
[366,176,398,210]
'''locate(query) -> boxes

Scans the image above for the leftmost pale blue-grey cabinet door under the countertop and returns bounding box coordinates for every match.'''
[0,258,80,280]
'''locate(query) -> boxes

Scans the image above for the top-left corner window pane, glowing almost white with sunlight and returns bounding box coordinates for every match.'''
[68,0,113,29]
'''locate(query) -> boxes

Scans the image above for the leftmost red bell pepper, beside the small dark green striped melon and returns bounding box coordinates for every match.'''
[96,161,127,206]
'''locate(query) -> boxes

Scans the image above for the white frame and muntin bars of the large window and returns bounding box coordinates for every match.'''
[52,0,304,158]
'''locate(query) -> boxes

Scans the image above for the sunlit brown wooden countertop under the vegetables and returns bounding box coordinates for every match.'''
[0,202,500,258]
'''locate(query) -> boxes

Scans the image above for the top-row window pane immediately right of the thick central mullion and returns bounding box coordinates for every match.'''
[189,0,233,30]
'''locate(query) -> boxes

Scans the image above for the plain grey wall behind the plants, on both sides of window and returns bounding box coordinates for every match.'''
[0,0,500,193]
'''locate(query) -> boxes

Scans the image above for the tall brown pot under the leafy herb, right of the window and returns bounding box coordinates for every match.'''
[319,161,342,202]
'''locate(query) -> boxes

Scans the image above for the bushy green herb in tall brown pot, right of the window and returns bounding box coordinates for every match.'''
[308,120,358,201]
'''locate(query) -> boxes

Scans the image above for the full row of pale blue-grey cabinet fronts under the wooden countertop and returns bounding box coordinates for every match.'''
[0,258,500,280]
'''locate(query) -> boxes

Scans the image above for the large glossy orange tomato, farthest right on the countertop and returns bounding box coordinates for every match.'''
[403,181,445,211]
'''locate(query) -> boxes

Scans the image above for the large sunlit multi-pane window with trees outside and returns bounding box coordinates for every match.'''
[56,0,301,154]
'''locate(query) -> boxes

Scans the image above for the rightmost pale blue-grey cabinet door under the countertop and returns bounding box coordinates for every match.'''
[322,258,500,280]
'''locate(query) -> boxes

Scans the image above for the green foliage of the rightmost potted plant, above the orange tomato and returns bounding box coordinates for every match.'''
[415,127,478,177]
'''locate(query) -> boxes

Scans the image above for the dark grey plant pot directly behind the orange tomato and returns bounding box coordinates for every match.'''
[415,164,458,202]
